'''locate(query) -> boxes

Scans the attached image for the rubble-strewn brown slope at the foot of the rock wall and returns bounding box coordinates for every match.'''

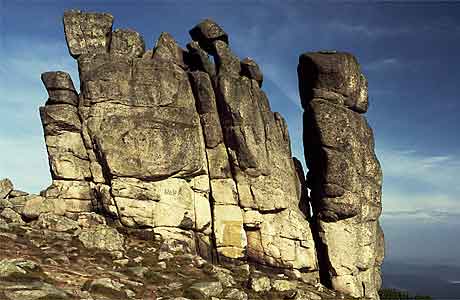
[0,213,340,300]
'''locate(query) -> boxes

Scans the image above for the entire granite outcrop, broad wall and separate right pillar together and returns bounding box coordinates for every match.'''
[0,10,383,299]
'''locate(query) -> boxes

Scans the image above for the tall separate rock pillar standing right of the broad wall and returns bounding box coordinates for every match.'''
[298,52,384,299]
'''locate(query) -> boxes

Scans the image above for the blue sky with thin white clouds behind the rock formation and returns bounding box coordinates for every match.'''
[0,0,460,265]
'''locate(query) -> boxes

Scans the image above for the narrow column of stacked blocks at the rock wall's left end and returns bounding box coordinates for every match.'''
[40,71,94,213]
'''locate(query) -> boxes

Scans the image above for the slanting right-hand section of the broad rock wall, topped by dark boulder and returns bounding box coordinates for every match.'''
[190,19,318,281]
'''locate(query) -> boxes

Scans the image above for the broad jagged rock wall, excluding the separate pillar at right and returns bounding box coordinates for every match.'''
[41,11,319,281]
